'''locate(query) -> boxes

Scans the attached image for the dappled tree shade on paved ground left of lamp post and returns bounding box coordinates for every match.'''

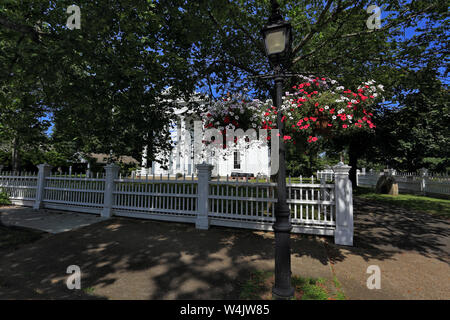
[0,218,328,299]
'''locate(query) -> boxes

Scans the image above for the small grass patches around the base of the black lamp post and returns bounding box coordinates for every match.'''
[240,271,346,300]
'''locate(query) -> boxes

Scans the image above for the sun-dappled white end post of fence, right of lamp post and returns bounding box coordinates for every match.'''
[333,162,353,246]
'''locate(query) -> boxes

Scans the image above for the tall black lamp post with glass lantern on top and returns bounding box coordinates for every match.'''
[262,0,294,299]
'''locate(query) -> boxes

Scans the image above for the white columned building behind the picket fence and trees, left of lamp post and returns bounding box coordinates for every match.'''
[137,103,270,177]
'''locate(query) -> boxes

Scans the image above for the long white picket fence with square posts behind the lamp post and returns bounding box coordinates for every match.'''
[0,164,353,245]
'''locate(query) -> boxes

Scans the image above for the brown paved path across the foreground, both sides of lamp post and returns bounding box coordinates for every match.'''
[0,200,450,299]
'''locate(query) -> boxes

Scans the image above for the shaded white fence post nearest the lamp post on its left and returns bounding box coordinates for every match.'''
[195,163,213,230]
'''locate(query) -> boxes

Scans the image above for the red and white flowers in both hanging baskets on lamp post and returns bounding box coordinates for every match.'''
[202,77,383,143]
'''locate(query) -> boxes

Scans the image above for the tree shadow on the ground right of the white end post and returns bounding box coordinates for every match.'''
[328,197,450,263]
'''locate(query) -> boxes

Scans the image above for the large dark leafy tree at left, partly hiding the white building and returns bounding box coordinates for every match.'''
[0,0,203,168]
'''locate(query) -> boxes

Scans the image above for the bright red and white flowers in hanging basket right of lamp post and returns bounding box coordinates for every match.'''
[263,77,383,143]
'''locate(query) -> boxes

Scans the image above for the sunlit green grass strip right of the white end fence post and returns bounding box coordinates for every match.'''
[354,187,450,219]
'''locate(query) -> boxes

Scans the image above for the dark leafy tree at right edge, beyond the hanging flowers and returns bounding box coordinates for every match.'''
[372,63,450,172]
